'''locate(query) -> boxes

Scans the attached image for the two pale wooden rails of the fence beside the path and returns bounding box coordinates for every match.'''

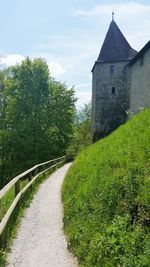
[0,156,66,242]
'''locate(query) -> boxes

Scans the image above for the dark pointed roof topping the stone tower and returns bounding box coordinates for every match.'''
[98,20,137,62]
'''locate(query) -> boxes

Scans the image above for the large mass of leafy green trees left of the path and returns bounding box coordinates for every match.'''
[0,57,76,187]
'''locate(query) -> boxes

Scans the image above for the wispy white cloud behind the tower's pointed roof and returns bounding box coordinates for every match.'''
[74,1,150,50]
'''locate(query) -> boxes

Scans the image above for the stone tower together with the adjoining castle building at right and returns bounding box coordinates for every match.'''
[92,17,150,142]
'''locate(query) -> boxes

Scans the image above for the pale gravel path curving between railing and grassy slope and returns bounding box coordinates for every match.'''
[8,164,77,267]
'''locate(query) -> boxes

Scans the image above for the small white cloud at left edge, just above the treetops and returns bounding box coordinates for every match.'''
[0,54,25,67]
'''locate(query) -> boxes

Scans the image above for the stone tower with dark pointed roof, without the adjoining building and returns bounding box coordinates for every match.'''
[92,16,137,142]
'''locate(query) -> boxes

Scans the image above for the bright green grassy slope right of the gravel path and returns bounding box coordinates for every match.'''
[62,109,150,267]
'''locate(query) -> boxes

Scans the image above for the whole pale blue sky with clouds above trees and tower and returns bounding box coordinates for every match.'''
[0,0,150,108]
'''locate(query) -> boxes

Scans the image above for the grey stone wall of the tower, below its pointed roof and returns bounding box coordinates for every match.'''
[92,61,129,142]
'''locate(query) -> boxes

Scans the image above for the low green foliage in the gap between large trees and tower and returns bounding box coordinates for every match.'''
[67,102,91,158]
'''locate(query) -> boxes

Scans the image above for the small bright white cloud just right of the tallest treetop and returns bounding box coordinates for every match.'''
[48,60,67,77]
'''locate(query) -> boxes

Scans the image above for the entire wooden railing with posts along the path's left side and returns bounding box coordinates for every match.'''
[0,156,66,244]
